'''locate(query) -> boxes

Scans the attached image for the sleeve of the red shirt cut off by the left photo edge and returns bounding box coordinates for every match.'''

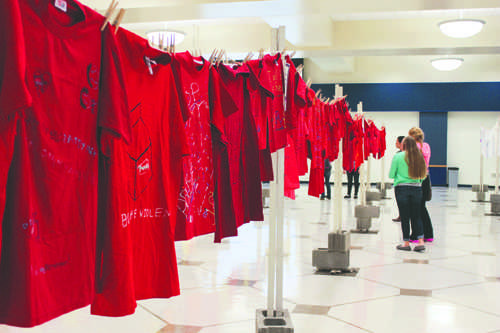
[0,1,31,113]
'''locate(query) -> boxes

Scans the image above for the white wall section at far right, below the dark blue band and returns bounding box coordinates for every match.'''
[448,112,500,185]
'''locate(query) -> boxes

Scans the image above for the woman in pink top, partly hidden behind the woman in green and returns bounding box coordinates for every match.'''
[408,127,434,242]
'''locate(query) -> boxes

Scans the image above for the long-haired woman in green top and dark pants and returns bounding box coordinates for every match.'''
[389,136,427,252]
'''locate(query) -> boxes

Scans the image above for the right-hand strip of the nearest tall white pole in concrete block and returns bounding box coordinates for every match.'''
[276,26,288,311]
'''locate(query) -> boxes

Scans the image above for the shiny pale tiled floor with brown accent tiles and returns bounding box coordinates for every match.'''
[0,187,500,333]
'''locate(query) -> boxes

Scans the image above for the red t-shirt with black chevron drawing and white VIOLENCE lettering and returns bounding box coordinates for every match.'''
[91,29,187,316]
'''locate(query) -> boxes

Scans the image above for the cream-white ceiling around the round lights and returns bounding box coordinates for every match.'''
[82,0,500,83]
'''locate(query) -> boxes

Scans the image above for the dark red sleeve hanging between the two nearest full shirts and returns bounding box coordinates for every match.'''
[98,26,131,147]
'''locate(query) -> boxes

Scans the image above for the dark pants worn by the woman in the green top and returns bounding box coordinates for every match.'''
[395,185,424,242]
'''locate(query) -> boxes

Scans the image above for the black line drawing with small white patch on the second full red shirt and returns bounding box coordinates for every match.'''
[127,103,153,200]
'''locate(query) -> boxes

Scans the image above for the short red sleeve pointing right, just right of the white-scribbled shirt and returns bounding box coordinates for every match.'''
[209,67,238,133]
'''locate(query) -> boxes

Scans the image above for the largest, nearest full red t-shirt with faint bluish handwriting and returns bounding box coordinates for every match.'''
[0,0,130,327]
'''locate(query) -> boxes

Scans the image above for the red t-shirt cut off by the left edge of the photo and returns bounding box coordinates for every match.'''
[0,1,31,258]
